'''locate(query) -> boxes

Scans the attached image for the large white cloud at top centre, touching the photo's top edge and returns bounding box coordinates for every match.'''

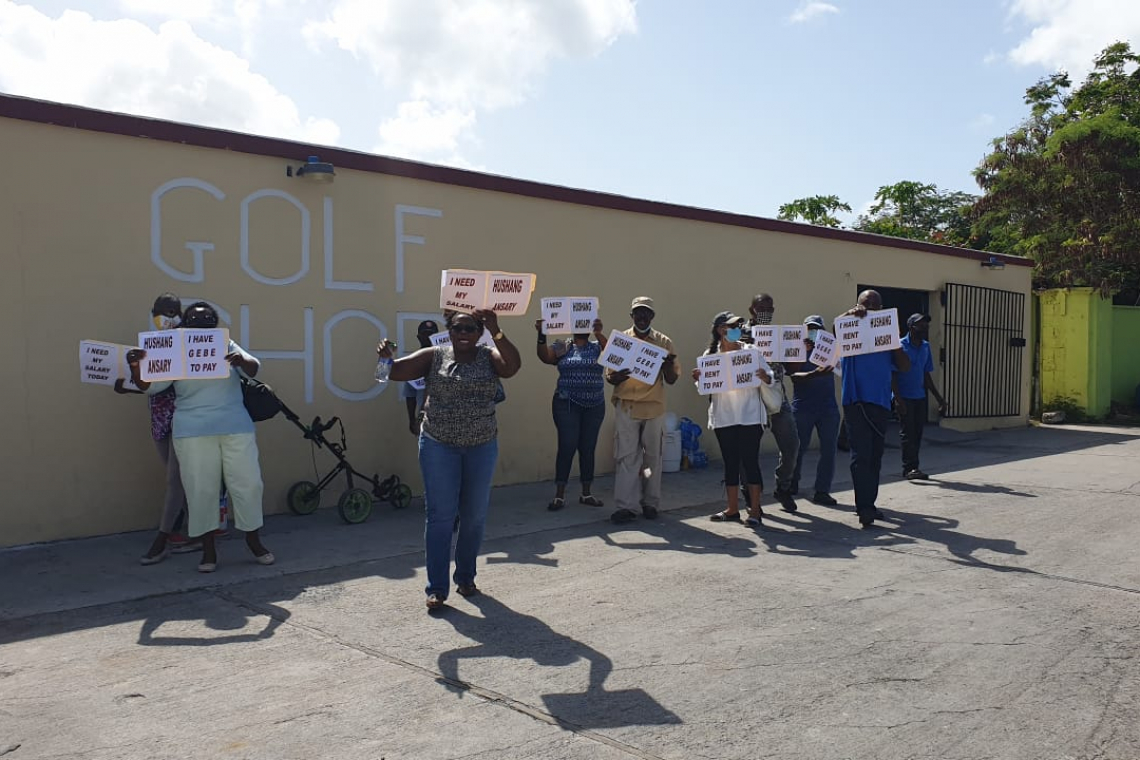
[306,0,637,162]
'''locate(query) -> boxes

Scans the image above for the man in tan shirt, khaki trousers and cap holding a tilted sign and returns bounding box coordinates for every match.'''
[605,295,679,523]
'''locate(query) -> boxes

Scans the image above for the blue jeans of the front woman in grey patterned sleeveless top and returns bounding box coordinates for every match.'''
[420,434,498,599]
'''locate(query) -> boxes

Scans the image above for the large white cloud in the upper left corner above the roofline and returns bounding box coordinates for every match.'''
[0,0,340,144]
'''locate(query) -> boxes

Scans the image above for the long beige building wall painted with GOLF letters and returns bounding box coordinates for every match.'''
[0,108,1029,546]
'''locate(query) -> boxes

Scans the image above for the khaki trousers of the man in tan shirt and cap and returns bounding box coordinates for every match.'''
[613,404,665,512]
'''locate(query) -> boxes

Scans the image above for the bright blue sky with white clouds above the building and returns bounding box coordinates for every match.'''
[0,0,1140,216]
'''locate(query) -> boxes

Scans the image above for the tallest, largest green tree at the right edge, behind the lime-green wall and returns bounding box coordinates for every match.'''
[974,42,1140,295]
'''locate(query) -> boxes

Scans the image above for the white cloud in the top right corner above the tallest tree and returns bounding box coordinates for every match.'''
[1009,0,1140,81]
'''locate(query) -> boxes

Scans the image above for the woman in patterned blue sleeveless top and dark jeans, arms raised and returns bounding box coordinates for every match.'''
[535,319,605,512]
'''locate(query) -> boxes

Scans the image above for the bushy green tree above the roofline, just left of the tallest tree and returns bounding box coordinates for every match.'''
[853,180,977,246]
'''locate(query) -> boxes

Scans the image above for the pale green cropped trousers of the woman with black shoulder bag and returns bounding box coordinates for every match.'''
[174,433,263,538]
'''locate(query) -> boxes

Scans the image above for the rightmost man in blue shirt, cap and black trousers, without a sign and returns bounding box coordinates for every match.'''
[894,314,946,481]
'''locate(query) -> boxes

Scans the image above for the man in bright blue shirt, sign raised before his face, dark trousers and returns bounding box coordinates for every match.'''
[842,291,911,530]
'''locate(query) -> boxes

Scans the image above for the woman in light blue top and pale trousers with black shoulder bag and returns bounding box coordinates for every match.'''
[127,301,274,573]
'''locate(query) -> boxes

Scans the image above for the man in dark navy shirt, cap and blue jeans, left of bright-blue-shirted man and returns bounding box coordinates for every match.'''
[791,314,839,507]
